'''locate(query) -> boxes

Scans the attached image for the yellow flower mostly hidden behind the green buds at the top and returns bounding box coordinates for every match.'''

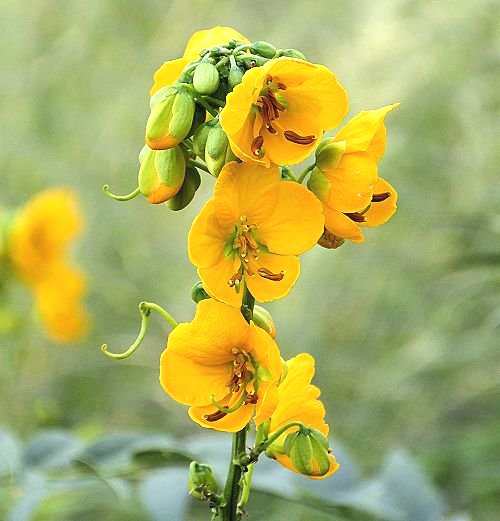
[150,27,250,96]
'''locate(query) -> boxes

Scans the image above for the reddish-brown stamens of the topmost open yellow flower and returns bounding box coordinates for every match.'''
[250,74,316,157]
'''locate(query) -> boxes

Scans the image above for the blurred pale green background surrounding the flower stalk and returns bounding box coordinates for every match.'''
[0,0,500,521]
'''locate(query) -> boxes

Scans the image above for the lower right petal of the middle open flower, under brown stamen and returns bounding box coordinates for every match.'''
[245,253,300,302]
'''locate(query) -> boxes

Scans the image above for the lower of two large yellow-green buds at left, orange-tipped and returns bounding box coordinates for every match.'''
[139,147,186,204]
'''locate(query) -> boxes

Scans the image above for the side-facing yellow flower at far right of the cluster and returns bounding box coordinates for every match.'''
[308,103,399,243]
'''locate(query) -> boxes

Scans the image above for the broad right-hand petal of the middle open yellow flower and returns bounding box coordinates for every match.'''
[256,181,325,255]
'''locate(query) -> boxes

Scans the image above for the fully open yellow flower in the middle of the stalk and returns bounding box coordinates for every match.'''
[188,162,324,307]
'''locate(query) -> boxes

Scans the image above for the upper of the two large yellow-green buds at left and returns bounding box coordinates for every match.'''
[146,86,195,150]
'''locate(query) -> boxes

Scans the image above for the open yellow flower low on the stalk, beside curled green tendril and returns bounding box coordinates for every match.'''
[160,299,282,432]
